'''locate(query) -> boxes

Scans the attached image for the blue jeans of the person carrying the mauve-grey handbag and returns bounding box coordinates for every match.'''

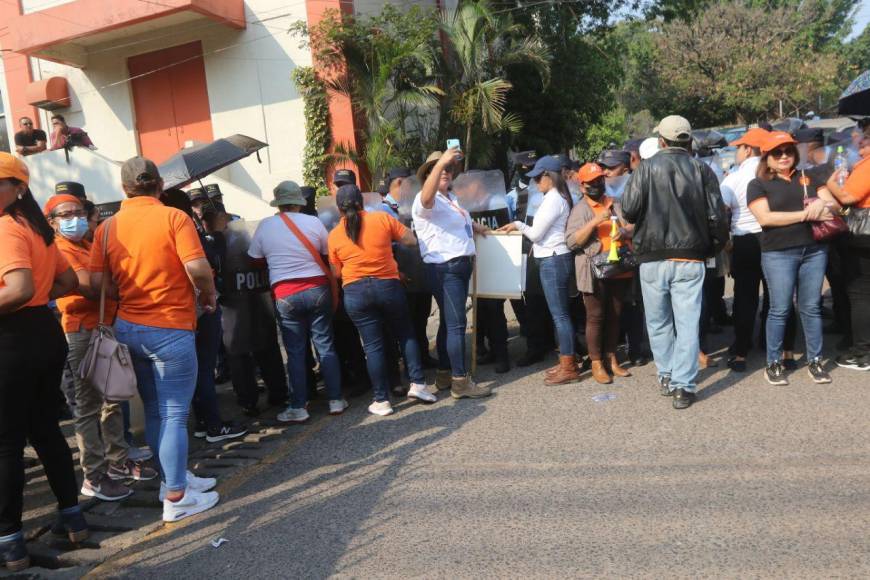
[115,318,197,491]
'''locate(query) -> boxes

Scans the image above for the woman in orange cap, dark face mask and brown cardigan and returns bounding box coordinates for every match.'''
[565,163,633,384]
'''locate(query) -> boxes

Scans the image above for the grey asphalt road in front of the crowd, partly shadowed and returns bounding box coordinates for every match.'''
[94,324,870,579]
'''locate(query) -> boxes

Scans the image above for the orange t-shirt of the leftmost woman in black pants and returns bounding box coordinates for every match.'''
[0,215,69,308]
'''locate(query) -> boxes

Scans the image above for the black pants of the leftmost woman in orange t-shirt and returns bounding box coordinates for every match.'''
[0,306,78,536]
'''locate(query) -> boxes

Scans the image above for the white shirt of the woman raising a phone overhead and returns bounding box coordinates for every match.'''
[411,191,475,264]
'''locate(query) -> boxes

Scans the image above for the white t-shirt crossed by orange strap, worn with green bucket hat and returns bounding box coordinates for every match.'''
[248,212,329,286]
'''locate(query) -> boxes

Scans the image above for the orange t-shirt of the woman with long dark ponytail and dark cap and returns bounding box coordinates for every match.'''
[329,211,407,286]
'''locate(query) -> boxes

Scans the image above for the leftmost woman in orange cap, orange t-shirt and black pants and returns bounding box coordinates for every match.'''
[0,152,88,571]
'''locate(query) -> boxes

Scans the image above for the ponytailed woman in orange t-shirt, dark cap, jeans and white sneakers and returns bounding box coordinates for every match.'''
[329,185,437,416]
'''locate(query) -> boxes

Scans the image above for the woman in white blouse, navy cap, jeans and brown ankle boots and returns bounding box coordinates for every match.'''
[500,155,580,385]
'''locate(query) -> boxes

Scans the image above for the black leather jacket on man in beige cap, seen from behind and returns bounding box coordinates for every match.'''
[622,147,728,262]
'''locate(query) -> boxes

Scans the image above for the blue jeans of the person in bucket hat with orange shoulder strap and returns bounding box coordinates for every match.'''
[275,285,341,409]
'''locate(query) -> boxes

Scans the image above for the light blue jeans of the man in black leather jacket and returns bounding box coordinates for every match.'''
[640,260,705,393]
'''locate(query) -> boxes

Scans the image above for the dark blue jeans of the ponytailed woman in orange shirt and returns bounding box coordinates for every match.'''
[344,278,426,402]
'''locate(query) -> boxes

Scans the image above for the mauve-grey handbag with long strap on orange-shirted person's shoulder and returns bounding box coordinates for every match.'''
[78,218,137,401]
